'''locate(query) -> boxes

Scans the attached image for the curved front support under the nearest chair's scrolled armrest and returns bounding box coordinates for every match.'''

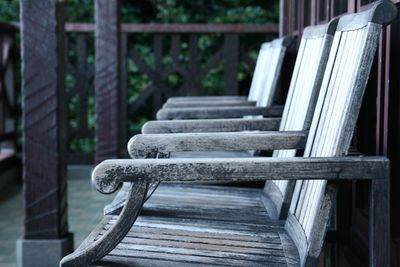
[60,180,148,267]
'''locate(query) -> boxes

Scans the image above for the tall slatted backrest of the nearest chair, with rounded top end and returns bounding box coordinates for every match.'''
[285,0,397,266]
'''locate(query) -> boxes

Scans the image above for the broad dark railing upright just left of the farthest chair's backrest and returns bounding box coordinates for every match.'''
[224,34,239,95]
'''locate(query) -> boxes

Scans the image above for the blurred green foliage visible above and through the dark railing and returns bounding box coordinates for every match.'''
[0,0,279,153]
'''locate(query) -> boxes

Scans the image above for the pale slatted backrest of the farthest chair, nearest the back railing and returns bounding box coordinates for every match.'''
[248,36,293,107]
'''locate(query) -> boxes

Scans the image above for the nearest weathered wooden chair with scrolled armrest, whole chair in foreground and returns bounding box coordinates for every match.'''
[61,1,397,266]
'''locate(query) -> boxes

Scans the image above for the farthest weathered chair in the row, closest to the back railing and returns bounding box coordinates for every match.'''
[157,37,293,120]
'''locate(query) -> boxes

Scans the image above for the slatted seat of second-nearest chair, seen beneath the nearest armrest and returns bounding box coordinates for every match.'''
[141,183,283,226]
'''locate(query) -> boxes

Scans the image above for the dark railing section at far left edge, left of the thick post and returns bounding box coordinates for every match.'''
[0,23,20,161]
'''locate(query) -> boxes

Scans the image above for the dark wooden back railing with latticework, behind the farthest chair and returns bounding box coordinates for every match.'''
[66,23,278,164]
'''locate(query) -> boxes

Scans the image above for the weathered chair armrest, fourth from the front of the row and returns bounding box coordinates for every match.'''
[157,106,283,120]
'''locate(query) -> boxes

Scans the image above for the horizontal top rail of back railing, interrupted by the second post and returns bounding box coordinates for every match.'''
[65,23,279,33]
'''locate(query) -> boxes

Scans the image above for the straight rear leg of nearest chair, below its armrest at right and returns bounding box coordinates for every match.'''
[369,178,390,267]
